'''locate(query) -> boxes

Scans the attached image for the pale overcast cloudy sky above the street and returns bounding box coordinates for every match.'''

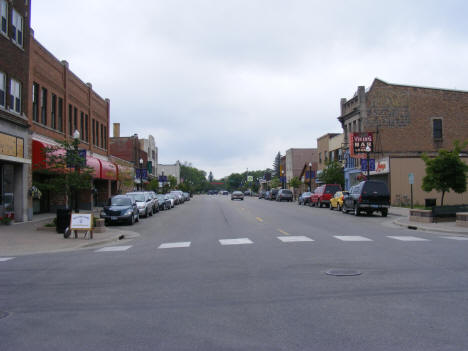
[31,0,468,178]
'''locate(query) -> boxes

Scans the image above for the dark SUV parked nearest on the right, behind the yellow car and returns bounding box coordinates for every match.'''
[342,180,390,217]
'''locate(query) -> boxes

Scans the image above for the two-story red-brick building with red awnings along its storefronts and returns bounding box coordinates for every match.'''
[27,34,118,213]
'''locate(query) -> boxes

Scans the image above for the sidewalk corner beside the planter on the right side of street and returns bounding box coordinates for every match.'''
[388,207,468,235]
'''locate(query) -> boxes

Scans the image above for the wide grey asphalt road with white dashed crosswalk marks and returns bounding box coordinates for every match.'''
[0,196,468,351]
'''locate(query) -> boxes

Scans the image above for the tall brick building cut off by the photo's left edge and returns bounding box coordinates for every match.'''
[0,0,32,221]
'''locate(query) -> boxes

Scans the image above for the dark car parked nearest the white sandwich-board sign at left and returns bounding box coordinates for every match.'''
[100,195,140,225]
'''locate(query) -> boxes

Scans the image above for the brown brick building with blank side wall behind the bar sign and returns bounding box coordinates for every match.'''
[338,79,468,204]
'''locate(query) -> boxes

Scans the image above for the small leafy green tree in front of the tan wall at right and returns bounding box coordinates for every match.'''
[421,141,468,206]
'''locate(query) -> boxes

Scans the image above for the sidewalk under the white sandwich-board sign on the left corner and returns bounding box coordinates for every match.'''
[0,214,139,257]
